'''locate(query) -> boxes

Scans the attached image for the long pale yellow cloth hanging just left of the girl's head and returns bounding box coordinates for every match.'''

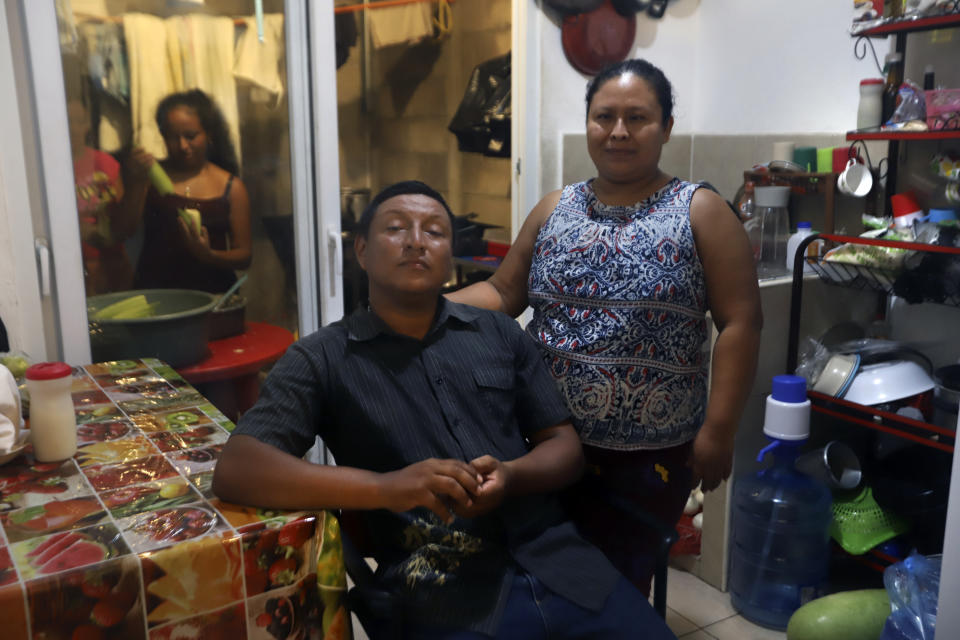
[123,13,183,158]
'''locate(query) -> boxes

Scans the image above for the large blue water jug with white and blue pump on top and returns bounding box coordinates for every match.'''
[728,376,833,629]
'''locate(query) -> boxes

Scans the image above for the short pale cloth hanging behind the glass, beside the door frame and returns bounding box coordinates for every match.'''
[233,13,284,104]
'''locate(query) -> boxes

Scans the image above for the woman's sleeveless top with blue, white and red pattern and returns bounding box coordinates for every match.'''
[527,178,709,450]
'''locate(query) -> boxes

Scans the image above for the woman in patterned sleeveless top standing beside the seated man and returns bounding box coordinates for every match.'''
[450,60,762,594]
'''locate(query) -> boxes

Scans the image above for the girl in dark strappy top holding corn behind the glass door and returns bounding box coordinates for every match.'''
[135,89,251,293]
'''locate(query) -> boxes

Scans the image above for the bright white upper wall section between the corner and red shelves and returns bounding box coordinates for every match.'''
[684,0,880,134]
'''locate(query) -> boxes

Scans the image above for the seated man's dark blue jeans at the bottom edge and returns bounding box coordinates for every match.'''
[403,572,676,640]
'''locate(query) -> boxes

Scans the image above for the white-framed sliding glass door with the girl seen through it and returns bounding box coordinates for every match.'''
[20,0,343,363]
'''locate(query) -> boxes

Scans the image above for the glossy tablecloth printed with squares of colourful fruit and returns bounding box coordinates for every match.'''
[0,359,350,640]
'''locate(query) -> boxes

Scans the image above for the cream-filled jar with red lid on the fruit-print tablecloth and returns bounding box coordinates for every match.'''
[24,362,77,462]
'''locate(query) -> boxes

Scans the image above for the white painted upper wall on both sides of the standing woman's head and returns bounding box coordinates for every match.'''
[531,0,892,191]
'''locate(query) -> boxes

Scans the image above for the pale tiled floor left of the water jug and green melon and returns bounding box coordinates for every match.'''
[353,567,787,640]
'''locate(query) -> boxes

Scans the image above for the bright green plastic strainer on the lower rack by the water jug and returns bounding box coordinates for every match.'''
[830,487,910,555]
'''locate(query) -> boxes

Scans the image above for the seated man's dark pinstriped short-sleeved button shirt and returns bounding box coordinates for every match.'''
[234,298,618,633]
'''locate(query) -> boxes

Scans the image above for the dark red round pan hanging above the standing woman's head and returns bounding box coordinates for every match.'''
[561,0,637,75]
